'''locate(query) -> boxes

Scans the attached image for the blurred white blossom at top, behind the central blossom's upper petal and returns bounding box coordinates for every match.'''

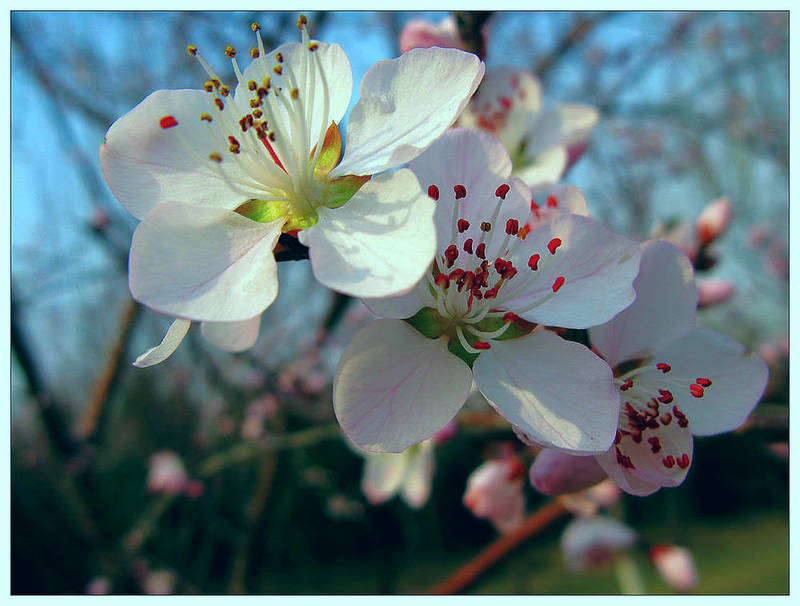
[459,67,599,191]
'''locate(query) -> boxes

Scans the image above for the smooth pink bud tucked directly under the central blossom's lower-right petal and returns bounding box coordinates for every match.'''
[529,449,606,495]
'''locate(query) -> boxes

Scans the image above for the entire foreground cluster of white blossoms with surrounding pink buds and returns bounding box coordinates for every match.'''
[100,16,768,567]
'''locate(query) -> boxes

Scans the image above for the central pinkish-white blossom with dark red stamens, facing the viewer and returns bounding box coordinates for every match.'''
[334,129,640,453]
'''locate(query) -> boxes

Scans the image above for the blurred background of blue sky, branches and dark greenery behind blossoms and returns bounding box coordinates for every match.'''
[11,12,789,594]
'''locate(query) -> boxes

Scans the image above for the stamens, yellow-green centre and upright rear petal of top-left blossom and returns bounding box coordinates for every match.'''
[160,15,369,232]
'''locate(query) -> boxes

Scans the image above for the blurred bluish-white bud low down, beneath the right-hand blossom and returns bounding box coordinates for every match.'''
[561,516,636,570]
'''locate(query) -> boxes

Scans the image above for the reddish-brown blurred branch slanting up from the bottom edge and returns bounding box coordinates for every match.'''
[430,501,568,595]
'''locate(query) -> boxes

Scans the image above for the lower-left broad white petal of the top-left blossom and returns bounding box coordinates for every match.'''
[129,202,283,322]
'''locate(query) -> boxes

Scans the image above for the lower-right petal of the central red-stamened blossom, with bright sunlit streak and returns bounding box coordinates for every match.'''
[473,330,619,454]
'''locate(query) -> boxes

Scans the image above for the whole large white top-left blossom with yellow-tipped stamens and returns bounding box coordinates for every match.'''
[100,16,484,366]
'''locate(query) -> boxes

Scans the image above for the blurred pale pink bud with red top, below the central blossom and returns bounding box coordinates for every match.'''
[464,464,525,533]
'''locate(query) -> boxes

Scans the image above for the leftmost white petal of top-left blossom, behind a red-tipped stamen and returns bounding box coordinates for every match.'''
[100,90,259,219]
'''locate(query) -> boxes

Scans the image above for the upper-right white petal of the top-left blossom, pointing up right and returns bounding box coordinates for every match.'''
[331,47,484,177]
